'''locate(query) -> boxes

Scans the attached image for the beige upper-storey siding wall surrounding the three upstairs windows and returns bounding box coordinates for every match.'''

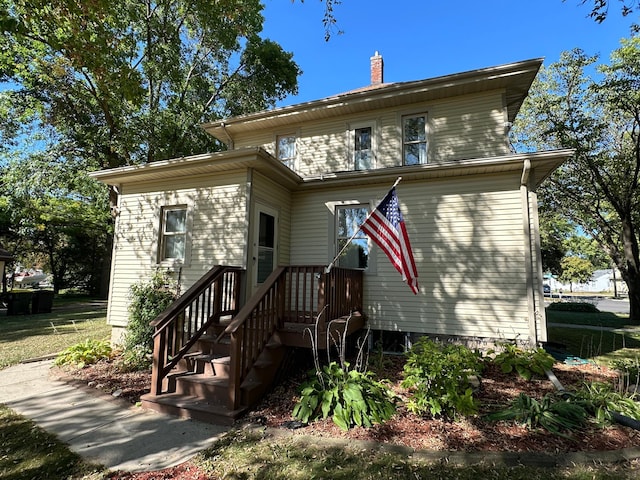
[234,91,509,176]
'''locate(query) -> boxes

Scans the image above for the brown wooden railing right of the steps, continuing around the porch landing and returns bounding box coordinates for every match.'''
[218,266,362,410]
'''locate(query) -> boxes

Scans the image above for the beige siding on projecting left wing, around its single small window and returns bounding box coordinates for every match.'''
[108,172,247,326]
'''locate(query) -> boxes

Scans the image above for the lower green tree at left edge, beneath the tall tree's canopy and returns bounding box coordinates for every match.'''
[0,154,111,294]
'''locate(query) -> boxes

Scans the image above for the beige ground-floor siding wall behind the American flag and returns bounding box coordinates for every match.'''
[291,175,529,344]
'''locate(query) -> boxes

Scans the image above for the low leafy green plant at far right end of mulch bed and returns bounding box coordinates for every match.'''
[572,382,640,425]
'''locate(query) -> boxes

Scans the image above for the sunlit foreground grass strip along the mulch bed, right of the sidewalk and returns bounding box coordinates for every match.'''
[194,430,640,480]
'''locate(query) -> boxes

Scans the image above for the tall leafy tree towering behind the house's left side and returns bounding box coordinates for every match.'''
[0,0,300,293]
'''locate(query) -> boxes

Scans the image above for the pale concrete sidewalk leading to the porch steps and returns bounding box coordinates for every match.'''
[0,360,227,472]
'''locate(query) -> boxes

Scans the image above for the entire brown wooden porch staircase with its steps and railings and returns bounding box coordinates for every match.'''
[141,266,364,424]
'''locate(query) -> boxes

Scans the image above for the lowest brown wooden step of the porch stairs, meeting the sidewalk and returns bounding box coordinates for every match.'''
[141,393,247,425]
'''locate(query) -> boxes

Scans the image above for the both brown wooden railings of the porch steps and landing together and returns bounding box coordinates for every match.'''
[151,265,362,410]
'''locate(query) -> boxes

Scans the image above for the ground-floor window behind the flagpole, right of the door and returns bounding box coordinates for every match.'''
[336,204,370,269]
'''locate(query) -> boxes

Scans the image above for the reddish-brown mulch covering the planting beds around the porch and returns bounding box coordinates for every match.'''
[55,357,640,480]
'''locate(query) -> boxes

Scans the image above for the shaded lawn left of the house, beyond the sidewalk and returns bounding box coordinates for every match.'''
[0,296,111,369]
